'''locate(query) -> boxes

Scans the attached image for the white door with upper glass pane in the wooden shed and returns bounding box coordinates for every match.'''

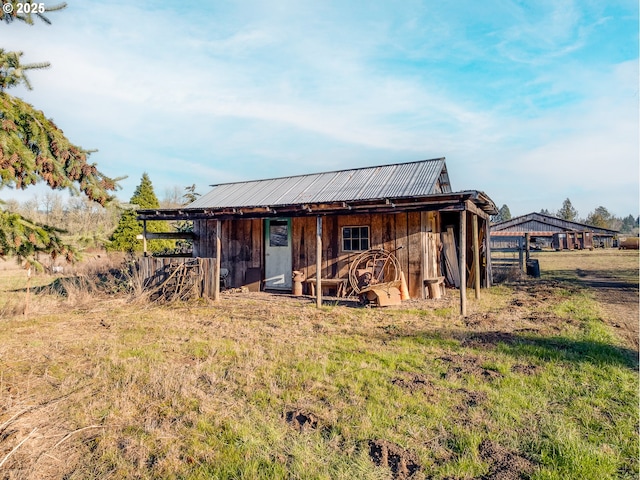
[264,218,291,290]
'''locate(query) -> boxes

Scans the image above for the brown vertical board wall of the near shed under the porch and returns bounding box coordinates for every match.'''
[193,211,441,298]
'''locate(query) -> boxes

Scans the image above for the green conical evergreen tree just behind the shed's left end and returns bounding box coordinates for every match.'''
[107,173,175,252]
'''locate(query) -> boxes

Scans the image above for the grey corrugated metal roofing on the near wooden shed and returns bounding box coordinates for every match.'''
[186,158,451,208]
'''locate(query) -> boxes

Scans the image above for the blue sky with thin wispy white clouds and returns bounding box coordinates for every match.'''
[0,0,639,217]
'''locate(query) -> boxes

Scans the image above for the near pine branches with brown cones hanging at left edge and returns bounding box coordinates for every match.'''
[0,0,118,265]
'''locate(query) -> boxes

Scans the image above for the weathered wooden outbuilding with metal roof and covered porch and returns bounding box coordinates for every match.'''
[138,158,497,312]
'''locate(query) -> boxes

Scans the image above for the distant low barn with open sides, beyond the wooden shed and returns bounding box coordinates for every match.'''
[491,213,618,250]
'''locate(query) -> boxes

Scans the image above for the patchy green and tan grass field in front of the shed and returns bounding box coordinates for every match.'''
[0,250,639,480]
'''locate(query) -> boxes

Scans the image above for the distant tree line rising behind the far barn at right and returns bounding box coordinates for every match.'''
[491,198,640,233]
